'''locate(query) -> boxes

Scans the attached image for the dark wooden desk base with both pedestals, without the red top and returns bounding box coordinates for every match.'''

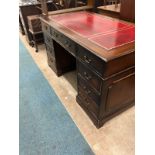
[42,19,134,128]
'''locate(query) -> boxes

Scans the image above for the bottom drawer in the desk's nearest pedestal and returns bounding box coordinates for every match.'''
[78,87,99,117]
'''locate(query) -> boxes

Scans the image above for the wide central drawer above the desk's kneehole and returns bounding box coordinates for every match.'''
[51,29,76,56]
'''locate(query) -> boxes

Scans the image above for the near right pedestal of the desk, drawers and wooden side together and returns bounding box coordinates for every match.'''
[77,45,134,128]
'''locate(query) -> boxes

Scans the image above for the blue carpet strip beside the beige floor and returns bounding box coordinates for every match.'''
[19,41,94,155]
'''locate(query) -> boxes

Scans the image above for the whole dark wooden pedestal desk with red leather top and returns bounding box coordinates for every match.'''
[41,11,135,128]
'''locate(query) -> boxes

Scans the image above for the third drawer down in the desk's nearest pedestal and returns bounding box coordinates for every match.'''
[77,76,100,105]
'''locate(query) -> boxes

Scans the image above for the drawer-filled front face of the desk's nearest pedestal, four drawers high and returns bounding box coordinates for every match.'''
[77,47,103,122]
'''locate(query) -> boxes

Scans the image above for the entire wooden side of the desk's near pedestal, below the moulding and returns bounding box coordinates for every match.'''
[99,66,135,122]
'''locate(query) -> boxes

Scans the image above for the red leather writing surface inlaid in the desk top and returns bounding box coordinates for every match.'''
[50,11,135,50]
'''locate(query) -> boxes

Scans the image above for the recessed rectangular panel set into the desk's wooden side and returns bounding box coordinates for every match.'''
[106,74,134,111]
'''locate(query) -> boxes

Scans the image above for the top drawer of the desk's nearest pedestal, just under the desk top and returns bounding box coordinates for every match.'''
[77,46,105,75]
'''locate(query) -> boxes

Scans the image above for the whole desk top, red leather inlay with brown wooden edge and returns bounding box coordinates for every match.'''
[41,11,135,61]
